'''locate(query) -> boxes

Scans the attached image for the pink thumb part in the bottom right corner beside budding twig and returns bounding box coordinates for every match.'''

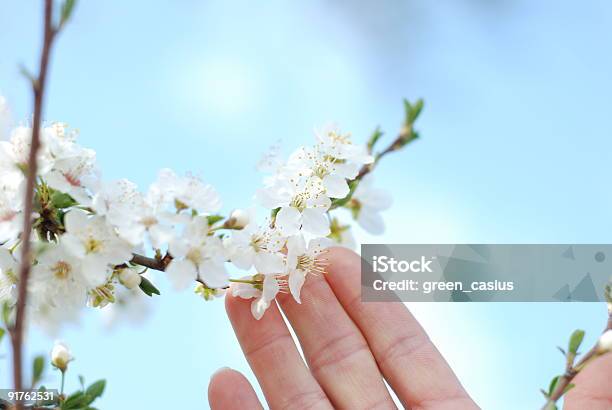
[564,353,612,410]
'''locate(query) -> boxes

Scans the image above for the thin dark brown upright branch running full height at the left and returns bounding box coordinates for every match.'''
[11,0,56,409]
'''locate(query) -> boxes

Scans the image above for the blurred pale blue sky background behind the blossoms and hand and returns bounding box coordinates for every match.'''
[0,0,612,409]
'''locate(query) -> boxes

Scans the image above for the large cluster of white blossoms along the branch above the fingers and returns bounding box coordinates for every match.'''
[0,113,390,332]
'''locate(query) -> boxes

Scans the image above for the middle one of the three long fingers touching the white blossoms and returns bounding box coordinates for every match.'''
[278,276,395,409]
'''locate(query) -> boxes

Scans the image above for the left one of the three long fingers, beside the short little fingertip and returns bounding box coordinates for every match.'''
[225,295,331,409]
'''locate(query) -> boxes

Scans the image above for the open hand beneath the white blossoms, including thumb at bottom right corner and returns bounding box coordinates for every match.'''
[208,248,612,410]
